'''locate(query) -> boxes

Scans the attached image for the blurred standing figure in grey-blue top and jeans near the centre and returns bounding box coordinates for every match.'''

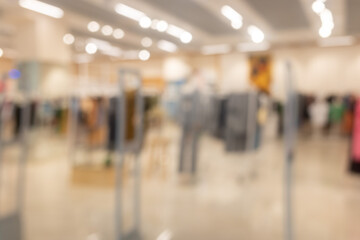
[178,69,211,176]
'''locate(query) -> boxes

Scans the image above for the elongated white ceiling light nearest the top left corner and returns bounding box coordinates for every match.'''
[19,0,64,18]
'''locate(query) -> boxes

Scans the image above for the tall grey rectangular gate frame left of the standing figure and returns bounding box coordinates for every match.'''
[115,69,144,240]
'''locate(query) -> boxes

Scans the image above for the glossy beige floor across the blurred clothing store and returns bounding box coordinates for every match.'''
[2,127,360,240]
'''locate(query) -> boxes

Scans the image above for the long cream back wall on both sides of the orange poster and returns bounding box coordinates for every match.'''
[67,43,360,99]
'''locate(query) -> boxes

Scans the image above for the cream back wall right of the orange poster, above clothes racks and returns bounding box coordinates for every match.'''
[273,46,360,95]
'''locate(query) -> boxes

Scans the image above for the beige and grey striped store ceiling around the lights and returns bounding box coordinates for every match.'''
[0,0,360,54]
